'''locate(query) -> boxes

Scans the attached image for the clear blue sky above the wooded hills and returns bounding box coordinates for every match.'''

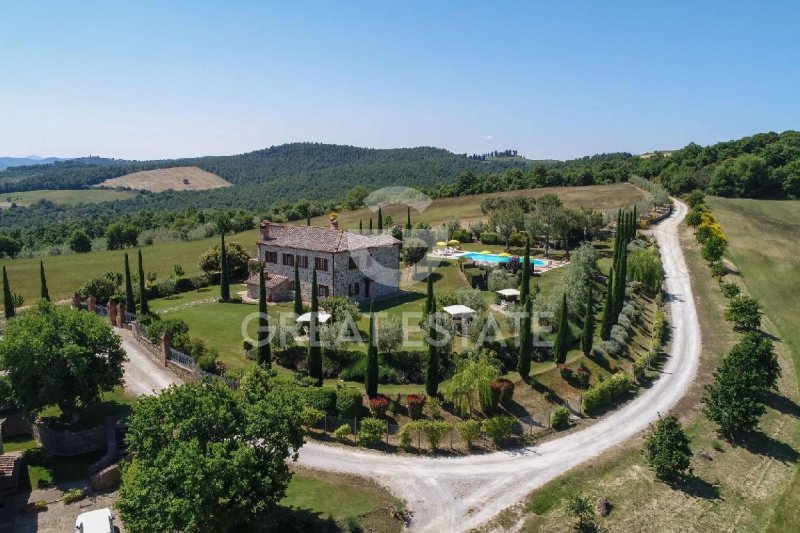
[0,1,800,159]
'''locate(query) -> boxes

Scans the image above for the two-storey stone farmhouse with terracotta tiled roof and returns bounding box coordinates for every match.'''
[247,218,400,303]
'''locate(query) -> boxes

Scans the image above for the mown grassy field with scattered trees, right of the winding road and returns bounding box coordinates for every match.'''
[498,199,800,532]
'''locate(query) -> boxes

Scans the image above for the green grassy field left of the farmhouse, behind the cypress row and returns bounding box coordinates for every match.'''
[0,230,257,305]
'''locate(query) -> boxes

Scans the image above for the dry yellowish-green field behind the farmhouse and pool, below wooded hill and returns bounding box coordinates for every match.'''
[311,183,646,228]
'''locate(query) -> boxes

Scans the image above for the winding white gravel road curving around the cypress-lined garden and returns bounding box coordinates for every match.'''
[298,201,701,532]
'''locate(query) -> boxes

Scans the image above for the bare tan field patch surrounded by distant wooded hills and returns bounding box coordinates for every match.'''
[98,167,231,192]
